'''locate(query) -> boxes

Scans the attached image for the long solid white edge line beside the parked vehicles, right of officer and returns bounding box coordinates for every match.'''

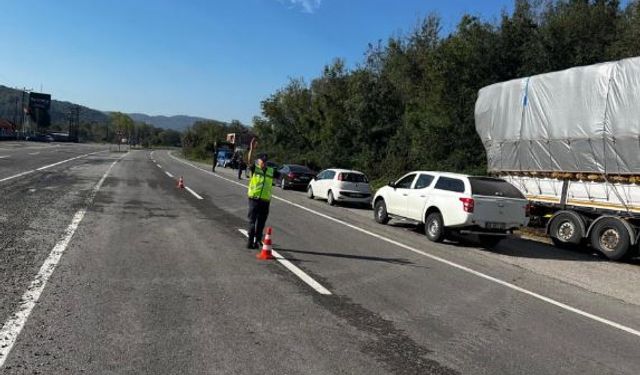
[169,152,640,337]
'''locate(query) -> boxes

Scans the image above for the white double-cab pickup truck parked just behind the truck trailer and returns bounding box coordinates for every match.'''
[372,171,529,246]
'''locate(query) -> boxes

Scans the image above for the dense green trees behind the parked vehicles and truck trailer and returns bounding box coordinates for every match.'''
[254,0,640,179]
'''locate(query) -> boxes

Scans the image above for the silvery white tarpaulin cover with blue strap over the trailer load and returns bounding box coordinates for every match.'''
[475,57,640,174]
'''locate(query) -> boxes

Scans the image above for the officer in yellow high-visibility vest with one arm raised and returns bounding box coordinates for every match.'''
[247,138,280,249]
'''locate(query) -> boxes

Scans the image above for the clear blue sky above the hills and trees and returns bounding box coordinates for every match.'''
[0,0,513,123]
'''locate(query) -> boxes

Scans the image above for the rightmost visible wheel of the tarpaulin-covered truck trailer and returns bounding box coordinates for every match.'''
[589,217,632,260]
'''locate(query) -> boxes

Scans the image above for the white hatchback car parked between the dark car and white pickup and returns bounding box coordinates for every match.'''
[307,169,371,206]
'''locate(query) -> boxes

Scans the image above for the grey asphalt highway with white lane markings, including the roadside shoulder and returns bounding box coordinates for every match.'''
[0,143,640,375]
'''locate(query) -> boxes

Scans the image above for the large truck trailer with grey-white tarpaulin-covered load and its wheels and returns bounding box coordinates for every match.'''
[475,57,640,260]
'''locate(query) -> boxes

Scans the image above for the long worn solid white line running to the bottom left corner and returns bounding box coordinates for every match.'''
[0,155,124,368]
